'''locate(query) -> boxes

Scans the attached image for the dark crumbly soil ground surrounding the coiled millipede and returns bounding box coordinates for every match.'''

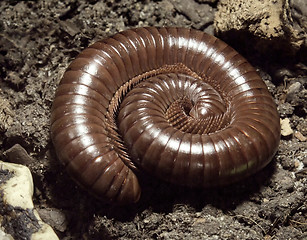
[0,0,307,240]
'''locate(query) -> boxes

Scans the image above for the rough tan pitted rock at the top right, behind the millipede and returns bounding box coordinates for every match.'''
[215,0,307,52]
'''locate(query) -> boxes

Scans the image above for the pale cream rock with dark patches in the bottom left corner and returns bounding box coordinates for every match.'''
[0,161,58,240]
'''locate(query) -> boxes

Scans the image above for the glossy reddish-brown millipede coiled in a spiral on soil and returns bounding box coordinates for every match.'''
[51,27,280,204]
